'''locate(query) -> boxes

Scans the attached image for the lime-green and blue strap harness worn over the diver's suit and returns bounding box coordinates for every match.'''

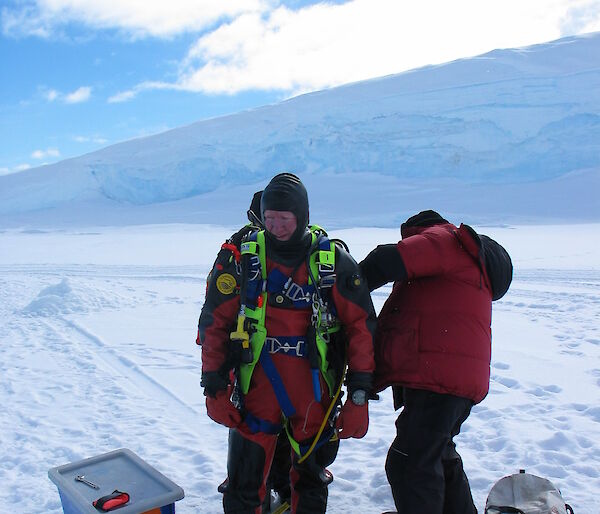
[230,225,343,457]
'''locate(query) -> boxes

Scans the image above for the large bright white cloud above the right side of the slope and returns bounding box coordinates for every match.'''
[169,0,600,94]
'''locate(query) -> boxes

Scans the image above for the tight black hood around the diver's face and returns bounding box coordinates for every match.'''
[260,173,308,239]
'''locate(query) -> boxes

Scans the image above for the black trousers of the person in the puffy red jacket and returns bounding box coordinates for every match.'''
[385,388,477,514]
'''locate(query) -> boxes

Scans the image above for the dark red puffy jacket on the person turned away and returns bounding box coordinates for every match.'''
[375,223,492,403]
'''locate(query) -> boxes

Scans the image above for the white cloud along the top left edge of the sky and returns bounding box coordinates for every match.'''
[2,0,272,37]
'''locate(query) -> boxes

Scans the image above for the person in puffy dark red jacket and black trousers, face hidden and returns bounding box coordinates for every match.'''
[360,210,512,514]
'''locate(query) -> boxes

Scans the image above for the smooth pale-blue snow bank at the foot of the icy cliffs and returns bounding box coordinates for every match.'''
[0,164,600,231]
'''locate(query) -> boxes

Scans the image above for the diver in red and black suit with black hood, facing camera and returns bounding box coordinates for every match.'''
[199,173,375,514]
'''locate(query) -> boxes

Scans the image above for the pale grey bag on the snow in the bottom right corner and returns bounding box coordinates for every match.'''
[485,470,573,514]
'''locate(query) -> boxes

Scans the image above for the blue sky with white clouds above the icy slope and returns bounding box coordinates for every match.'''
[0,0,600,174]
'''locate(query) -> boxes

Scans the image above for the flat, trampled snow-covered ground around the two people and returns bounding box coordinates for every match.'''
[0,220,600,514]
